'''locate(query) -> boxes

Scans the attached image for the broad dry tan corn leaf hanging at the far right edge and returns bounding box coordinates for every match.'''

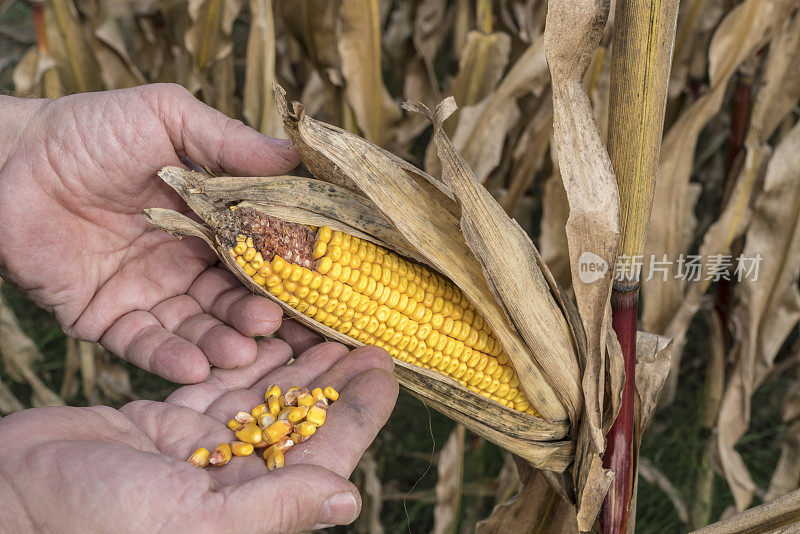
[718,124,800,510]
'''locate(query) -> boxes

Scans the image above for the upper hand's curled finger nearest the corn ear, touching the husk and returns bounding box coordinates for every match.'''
[187,268,283,336]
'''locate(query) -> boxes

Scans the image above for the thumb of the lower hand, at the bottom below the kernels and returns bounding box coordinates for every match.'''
[212,465,361,532]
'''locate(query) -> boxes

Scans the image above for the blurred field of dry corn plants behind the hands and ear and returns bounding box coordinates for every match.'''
[0,0,800,533]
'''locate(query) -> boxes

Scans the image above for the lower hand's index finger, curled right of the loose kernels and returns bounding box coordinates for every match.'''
[286,347,398,477]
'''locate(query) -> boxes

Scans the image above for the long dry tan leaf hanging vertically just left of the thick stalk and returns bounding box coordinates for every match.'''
[545,0,622,531]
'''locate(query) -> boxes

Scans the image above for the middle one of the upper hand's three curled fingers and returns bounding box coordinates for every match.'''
[150,295,256,368]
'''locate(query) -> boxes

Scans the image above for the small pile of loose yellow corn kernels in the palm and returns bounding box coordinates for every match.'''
[187,385,339,471]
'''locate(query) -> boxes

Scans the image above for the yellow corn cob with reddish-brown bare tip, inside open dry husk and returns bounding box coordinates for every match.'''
[221,208,536,415]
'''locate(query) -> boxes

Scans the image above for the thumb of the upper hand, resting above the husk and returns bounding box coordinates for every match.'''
[138,84,300,176]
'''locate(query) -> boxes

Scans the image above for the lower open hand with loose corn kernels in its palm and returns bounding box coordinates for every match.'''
[0,338,397,534]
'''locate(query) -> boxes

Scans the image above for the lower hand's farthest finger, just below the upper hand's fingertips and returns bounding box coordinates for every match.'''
[166,338,292,414]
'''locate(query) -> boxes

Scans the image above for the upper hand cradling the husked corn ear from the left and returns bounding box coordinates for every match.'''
[0,84,299,383]
